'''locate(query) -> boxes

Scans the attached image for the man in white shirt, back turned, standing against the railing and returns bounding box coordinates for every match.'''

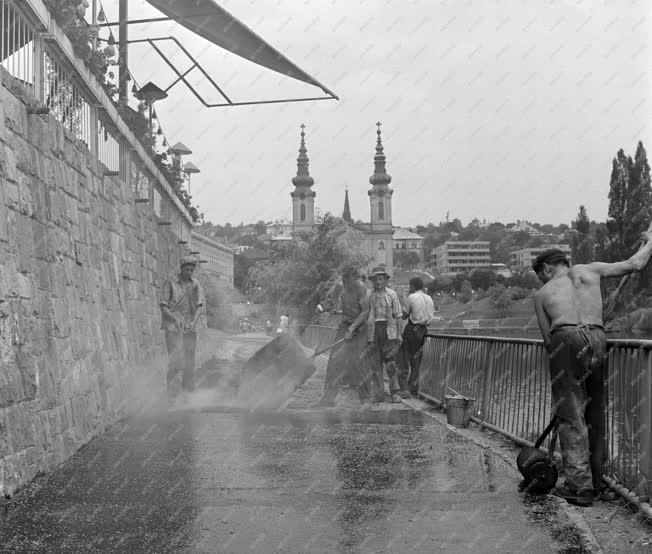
[397,277,435,398]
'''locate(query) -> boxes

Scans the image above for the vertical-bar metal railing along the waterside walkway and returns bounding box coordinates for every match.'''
[303,326,652,502]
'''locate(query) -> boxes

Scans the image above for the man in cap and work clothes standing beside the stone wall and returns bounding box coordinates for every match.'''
[160,252,205,393]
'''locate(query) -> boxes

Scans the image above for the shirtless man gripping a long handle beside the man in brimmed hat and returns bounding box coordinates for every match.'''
[317,267,371,407]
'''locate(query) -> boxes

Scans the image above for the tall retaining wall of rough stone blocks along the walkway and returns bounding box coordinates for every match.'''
[0,68,188,494]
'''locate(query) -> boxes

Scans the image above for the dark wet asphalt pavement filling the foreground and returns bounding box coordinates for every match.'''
[0,334,596,552]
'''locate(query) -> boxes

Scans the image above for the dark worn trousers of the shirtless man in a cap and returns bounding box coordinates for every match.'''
[549,325,607,491]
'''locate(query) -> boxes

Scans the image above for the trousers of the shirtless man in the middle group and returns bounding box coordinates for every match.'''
[324,321,367,402]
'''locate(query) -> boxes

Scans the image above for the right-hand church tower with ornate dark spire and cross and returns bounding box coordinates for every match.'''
[369,121,394,274]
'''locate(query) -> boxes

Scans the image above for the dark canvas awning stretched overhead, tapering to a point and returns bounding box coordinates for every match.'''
[147,0,336,97]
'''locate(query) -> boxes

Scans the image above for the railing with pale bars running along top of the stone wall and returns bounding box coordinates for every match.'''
[0,0,192,229]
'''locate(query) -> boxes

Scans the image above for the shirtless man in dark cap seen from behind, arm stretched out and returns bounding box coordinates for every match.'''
[532,232,652,506]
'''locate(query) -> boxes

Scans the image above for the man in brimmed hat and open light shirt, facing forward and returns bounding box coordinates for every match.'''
[367,266,403,402]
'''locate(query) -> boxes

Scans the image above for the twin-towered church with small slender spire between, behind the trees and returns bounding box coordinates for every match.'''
[290,122,394,275]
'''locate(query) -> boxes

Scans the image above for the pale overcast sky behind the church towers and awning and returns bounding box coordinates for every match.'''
[104,0,652,226]
